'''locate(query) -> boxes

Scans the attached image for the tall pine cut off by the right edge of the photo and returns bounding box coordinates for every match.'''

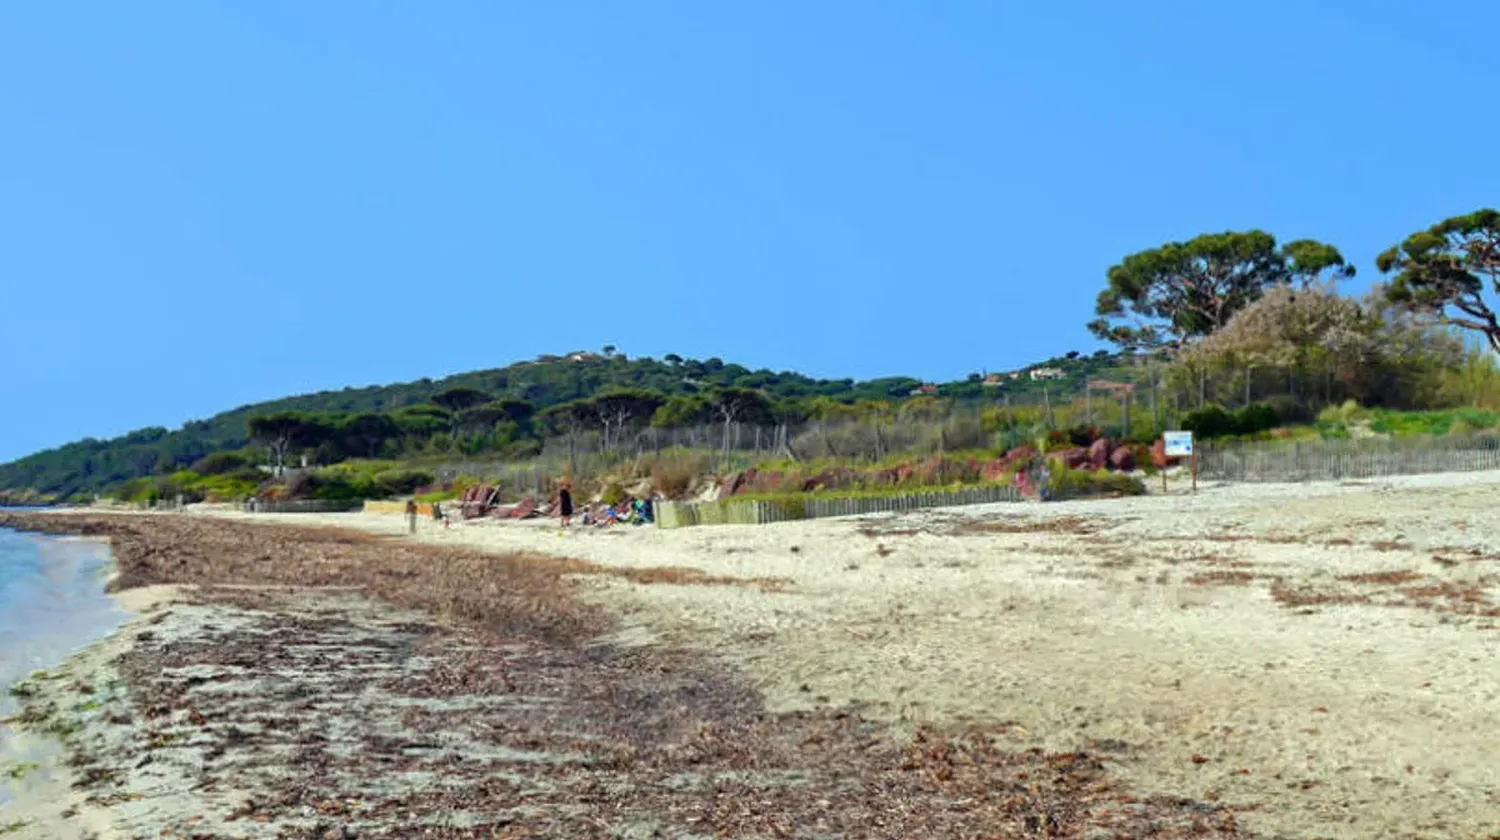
[1376,209,1500,351]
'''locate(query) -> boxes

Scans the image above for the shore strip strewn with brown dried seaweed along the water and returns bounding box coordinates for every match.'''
[0,513,1244,837]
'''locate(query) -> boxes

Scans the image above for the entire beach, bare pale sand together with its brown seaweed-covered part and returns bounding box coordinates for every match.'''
[0,474,1500,837]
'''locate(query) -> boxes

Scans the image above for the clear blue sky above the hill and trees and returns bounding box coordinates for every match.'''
[0,0,1500,461]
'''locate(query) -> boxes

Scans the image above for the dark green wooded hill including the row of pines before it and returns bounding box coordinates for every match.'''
[0,353,1115,498]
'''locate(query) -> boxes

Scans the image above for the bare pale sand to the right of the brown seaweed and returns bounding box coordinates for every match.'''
[187,473,1500,837]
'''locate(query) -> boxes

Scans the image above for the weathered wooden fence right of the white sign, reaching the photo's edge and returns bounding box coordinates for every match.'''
[1199,434,1500,482]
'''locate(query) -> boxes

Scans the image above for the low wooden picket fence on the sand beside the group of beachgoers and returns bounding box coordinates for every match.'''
[656,485,1022,528]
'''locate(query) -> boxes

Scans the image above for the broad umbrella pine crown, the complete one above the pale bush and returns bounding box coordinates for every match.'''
[1089,231,1355,351]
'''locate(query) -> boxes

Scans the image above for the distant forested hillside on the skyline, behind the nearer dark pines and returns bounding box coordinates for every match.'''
[0,353,1118,500]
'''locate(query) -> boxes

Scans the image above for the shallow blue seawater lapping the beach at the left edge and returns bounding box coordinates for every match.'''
[0,528,129,803]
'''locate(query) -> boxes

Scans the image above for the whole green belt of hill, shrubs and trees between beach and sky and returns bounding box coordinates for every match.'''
[0,210,1500,504]
